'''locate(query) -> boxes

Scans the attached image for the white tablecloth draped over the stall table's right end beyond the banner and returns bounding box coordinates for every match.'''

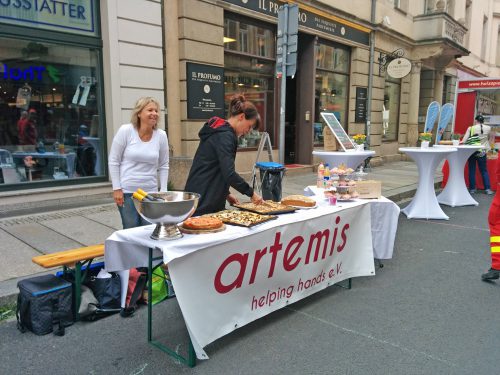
[304,185,400,259]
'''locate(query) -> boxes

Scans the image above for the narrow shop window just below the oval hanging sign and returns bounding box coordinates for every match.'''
[382,75,401,141]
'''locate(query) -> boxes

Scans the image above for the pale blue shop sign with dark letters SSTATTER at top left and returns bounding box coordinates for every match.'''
[0,0,98,36]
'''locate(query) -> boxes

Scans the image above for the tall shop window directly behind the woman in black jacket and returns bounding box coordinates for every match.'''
[224,13,276,148]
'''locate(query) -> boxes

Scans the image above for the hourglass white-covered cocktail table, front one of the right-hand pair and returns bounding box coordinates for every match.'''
[399,147,457,220]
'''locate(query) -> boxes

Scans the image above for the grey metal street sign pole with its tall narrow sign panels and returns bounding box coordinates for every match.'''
[276,4,299,165]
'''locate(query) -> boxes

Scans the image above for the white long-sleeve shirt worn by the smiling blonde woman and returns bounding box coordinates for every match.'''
[108,124,169,193]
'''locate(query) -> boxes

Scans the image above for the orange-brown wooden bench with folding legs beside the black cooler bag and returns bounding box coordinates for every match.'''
[31,244,104,320]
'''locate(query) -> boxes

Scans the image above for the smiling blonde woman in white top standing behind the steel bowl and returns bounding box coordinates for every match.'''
[108,97,169,317]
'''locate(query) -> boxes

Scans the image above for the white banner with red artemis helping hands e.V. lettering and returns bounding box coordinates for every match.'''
[169,204,375,359]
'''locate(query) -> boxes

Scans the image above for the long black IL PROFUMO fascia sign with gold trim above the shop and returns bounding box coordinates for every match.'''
[224,0,370,46]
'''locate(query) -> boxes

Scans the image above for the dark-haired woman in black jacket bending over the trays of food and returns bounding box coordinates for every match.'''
[185,95,262,215]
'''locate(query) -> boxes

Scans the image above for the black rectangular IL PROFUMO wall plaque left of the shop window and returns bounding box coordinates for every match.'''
[186,62,224,120]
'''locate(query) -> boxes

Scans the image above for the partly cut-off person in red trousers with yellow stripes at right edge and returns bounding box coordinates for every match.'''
[481,156,500,281]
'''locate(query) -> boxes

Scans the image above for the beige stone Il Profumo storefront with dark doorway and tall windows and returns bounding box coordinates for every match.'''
[165,0,370,186]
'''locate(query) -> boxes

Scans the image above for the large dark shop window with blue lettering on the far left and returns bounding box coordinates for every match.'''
[0,38,104,184]
